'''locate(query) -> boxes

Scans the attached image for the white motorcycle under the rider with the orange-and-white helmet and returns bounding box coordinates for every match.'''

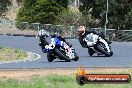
[84,33,113,57]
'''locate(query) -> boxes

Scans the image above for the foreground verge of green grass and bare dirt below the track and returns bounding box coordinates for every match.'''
[0,69,132,88]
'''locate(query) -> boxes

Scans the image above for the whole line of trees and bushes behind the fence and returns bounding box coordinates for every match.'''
[0,0,132,30]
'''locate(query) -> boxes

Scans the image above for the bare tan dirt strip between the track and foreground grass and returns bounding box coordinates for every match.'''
[0,68,131,79]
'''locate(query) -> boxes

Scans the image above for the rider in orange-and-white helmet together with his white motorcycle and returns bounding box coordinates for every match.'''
[78,26,113,57]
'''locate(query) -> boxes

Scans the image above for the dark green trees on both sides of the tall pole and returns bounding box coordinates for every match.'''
[79,0,132,29]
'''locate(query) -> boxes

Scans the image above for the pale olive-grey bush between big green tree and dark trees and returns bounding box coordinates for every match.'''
[58,7,96,26]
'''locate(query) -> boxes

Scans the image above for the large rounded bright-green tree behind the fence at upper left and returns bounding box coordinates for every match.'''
[16,0,68,24]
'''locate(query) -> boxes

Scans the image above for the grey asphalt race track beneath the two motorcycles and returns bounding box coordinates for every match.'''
[0,35,132,69]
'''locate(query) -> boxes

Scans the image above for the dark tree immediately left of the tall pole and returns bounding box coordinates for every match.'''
[79,0,105,26]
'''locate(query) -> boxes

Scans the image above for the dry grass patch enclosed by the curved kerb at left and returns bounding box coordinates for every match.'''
[0,47,27,62]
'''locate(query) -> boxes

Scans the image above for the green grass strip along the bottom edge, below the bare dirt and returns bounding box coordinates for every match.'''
[0,71,132,88]
